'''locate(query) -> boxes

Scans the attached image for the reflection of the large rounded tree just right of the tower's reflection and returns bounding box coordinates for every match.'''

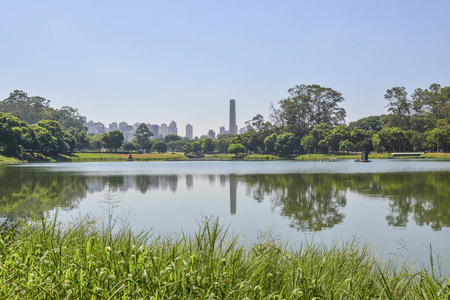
[244,174,347,231]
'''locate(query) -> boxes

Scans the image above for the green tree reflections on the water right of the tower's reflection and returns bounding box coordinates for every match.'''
[242,172,450,231]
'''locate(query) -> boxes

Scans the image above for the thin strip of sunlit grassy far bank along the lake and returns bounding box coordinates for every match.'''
[0,152,450,164]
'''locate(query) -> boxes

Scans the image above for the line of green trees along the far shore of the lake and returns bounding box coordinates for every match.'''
[0,83,450,157]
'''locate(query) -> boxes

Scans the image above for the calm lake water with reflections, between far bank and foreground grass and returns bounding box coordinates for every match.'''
[0,160,450,272]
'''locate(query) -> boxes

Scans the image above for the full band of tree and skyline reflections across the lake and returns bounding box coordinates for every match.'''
[0,168,450,231]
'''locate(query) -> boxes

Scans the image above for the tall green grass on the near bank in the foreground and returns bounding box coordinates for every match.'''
[0,216,450,299]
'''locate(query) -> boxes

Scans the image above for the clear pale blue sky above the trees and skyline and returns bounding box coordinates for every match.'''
[0,0,450,136]
